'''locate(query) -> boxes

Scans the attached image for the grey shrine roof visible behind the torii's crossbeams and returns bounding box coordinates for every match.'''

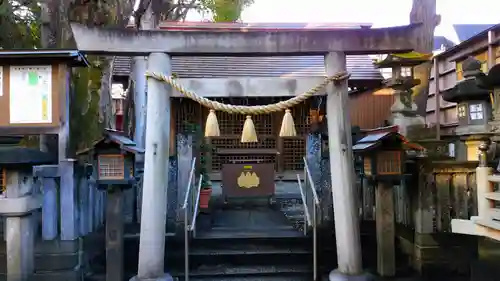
[113,21,383,81]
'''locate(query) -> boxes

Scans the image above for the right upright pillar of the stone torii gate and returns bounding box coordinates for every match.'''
[325,52,368,281]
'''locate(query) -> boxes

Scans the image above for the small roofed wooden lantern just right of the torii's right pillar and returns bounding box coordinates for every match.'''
[353,132,406,181]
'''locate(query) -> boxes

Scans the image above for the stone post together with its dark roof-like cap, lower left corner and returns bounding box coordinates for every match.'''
[0,136,56,280]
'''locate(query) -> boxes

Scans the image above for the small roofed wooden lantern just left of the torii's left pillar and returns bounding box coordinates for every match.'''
[79,130,144,189]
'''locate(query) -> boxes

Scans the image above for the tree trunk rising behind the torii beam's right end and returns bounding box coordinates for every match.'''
[410,0,441,117]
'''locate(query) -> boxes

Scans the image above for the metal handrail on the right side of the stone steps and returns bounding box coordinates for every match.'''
[298,157,320,280]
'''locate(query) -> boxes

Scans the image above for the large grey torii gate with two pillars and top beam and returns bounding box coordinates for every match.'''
[71,24,421,281]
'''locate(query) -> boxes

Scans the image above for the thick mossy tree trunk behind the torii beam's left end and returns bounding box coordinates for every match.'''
[41,0,134,154]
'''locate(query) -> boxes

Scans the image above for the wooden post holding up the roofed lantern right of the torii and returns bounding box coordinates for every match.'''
[375,182,396,277]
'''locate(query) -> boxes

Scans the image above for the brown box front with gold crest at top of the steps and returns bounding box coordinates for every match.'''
[222,163,274,197]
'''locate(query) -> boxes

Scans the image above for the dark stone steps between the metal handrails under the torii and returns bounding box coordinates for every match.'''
[167,204,312,281]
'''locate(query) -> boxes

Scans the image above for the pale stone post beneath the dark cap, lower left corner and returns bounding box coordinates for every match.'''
[0,171,42,281]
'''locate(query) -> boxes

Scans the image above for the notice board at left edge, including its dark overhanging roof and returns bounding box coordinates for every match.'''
[0,49,90,135]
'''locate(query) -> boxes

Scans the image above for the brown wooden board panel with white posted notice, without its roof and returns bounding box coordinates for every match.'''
[0,64,67,134]
